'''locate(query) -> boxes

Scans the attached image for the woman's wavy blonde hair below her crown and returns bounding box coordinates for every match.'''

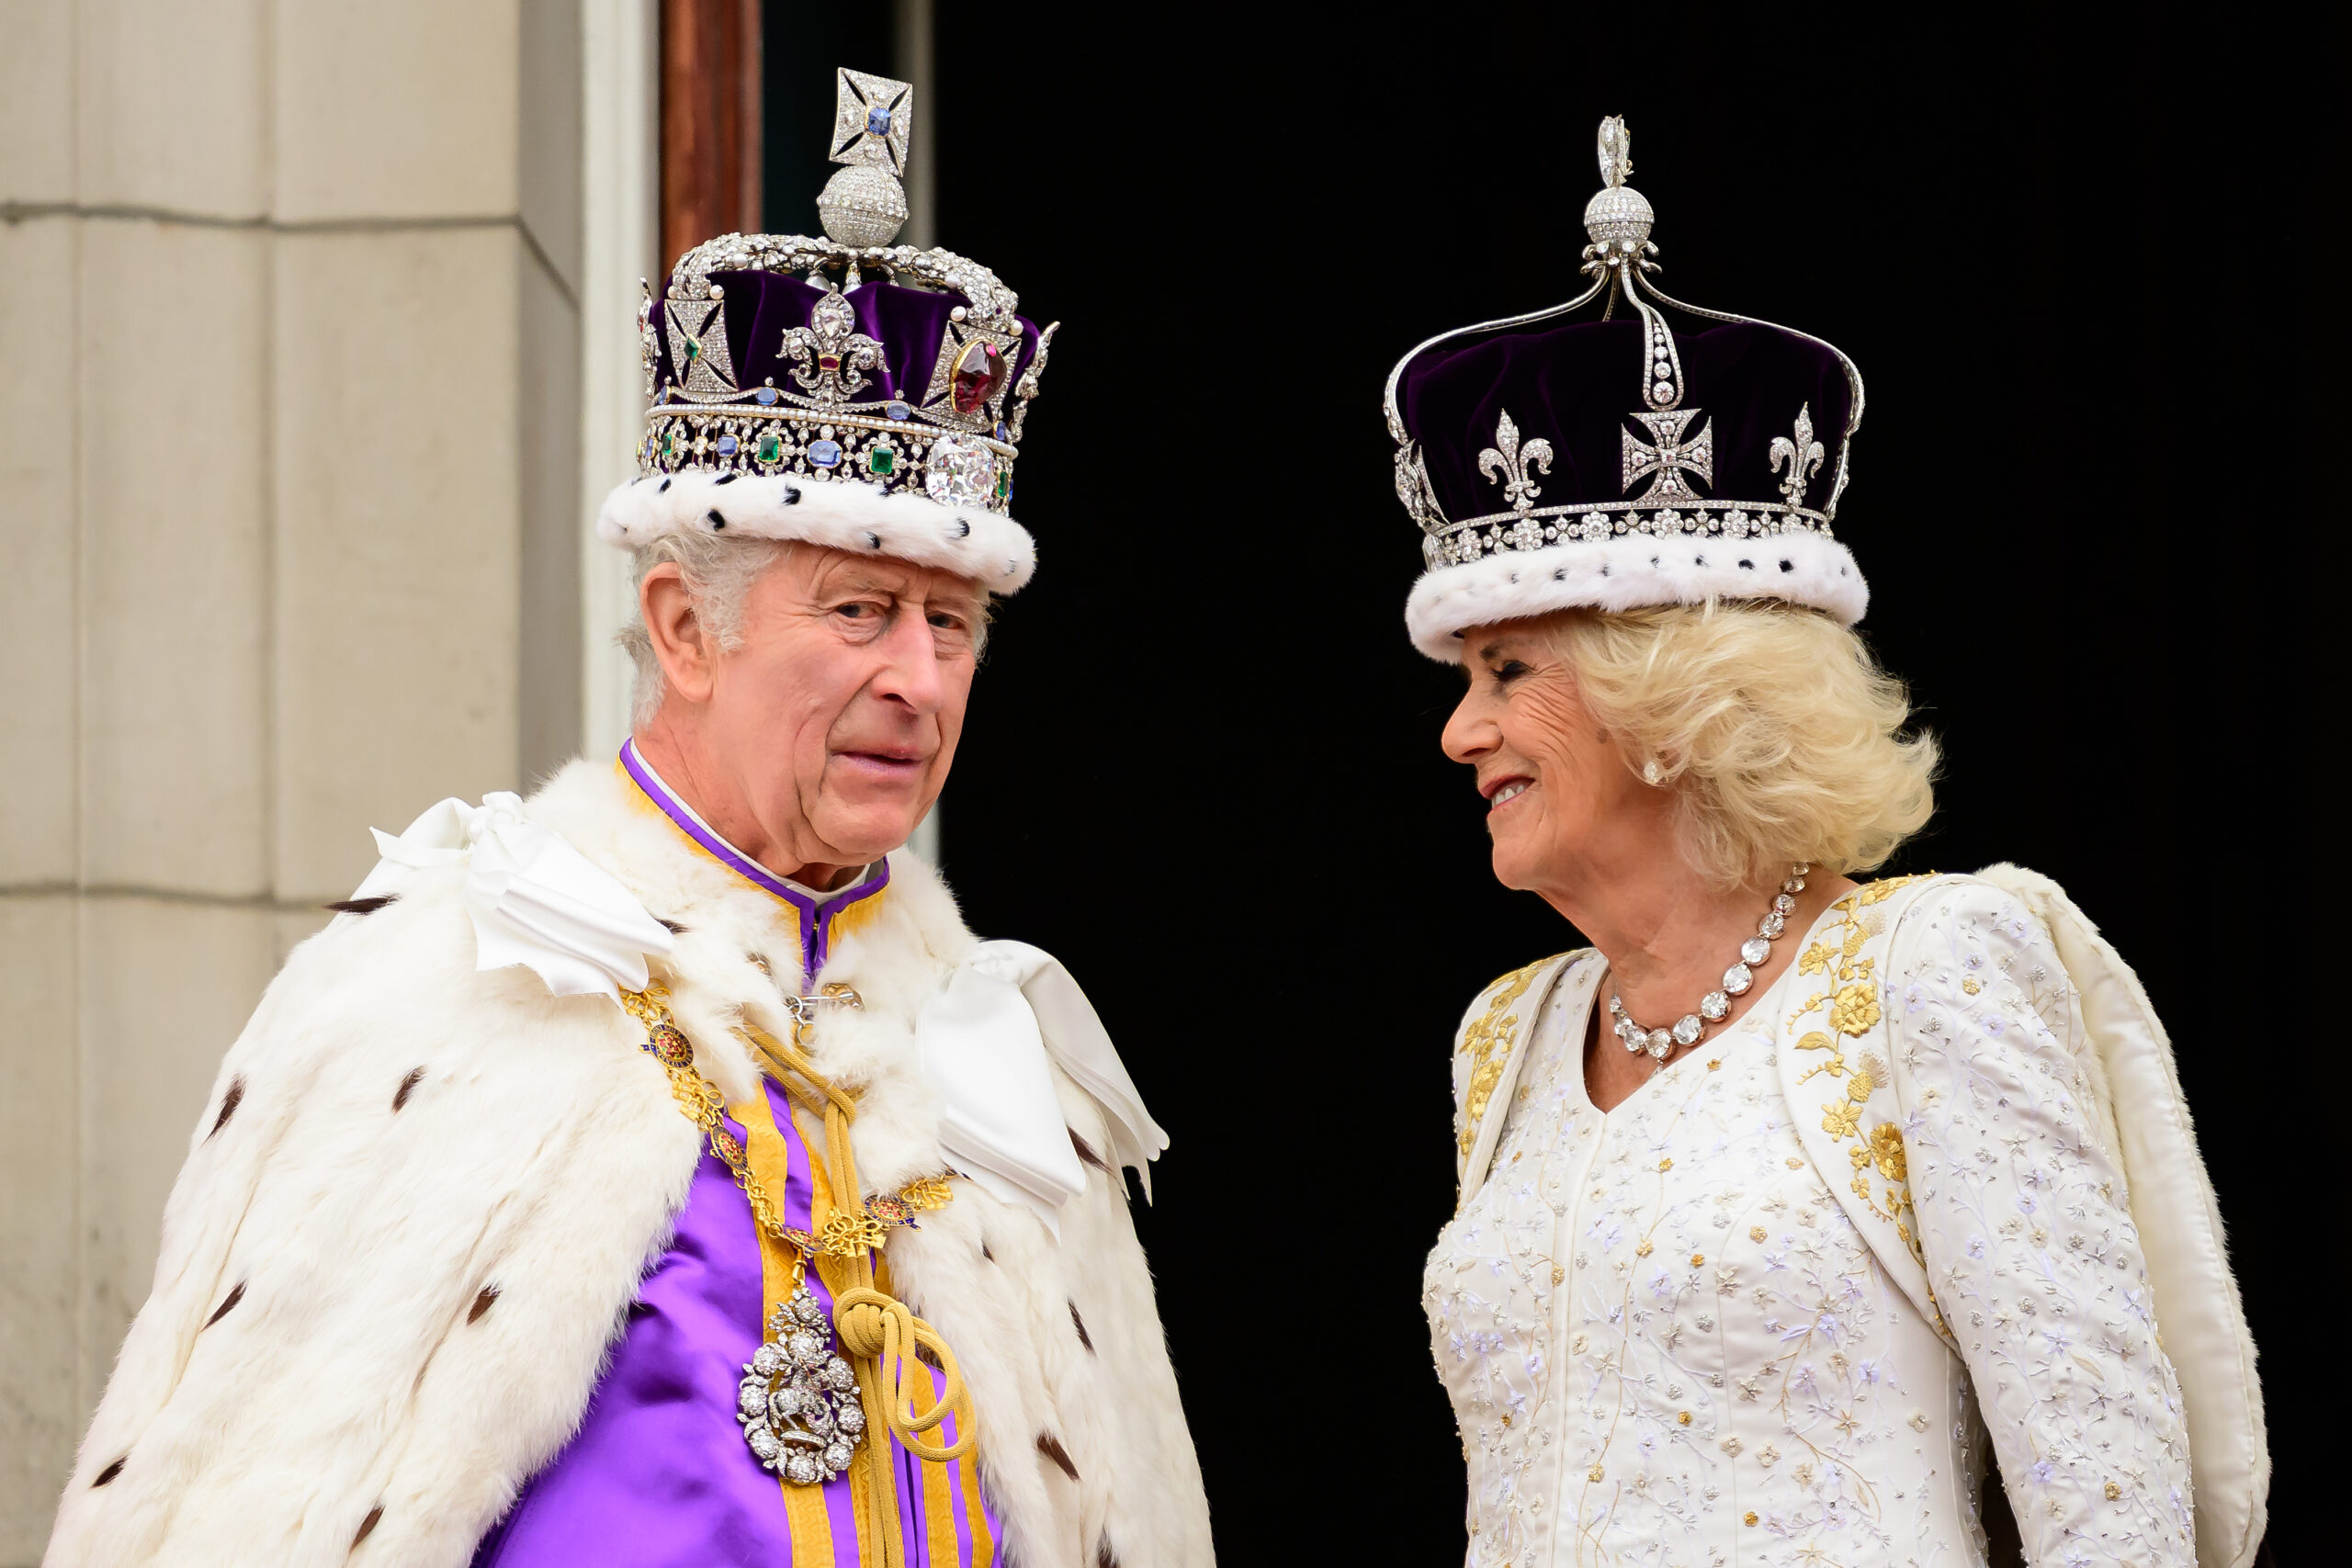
[1553,602,1938,886]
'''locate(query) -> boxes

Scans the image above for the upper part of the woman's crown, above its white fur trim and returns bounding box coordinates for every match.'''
[1383,115,1863,569]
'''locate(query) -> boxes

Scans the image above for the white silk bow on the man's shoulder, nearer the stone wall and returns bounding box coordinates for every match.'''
[353,790,673,1001]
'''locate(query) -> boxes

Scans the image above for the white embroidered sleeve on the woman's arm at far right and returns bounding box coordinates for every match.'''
[1884,879,2197,1568]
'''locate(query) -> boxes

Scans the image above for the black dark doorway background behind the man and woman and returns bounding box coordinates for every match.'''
[769,3,2347,1565]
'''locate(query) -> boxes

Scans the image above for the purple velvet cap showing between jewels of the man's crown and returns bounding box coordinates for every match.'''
[663,273,1037,421]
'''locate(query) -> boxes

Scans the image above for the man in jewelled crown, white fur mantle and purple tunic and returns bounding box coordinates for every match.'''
[47,73,1214,1568]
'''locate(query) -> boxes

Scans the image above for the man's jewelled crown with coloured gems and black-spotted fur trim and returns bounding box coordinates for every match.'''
[600,71,1058,592]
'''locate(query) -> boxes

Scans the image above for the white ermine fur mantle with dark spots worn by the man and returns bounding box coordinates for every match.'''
[45,761,1214,1568]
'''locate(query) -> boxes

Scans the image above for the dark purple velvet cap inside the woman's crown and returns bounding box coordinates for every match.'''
[1397,317,1853,522]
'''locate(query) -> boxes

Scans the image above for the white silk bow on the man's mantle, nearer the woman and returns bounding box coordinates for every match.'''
[915,942,1169,1239]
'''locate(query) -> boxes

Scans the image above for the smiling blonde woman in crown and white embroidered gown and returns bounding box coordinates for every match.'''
[1387,120,2267,1568]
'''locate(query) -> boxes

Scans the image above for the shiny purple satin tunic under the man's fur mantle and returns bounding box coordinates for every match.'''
[473,1084,1002,1568]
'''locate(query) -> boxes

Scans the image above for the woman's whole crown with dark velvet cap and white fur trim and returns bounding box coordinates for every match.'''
[1385,118,1868,660]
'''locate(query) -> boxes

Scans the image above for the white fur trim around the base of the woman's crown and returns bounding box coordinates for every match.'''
[1404,534,1870,663]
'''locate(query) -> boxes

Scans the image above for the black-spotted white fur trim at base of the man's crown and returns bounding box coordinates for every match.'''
[595,472,1037,594]
